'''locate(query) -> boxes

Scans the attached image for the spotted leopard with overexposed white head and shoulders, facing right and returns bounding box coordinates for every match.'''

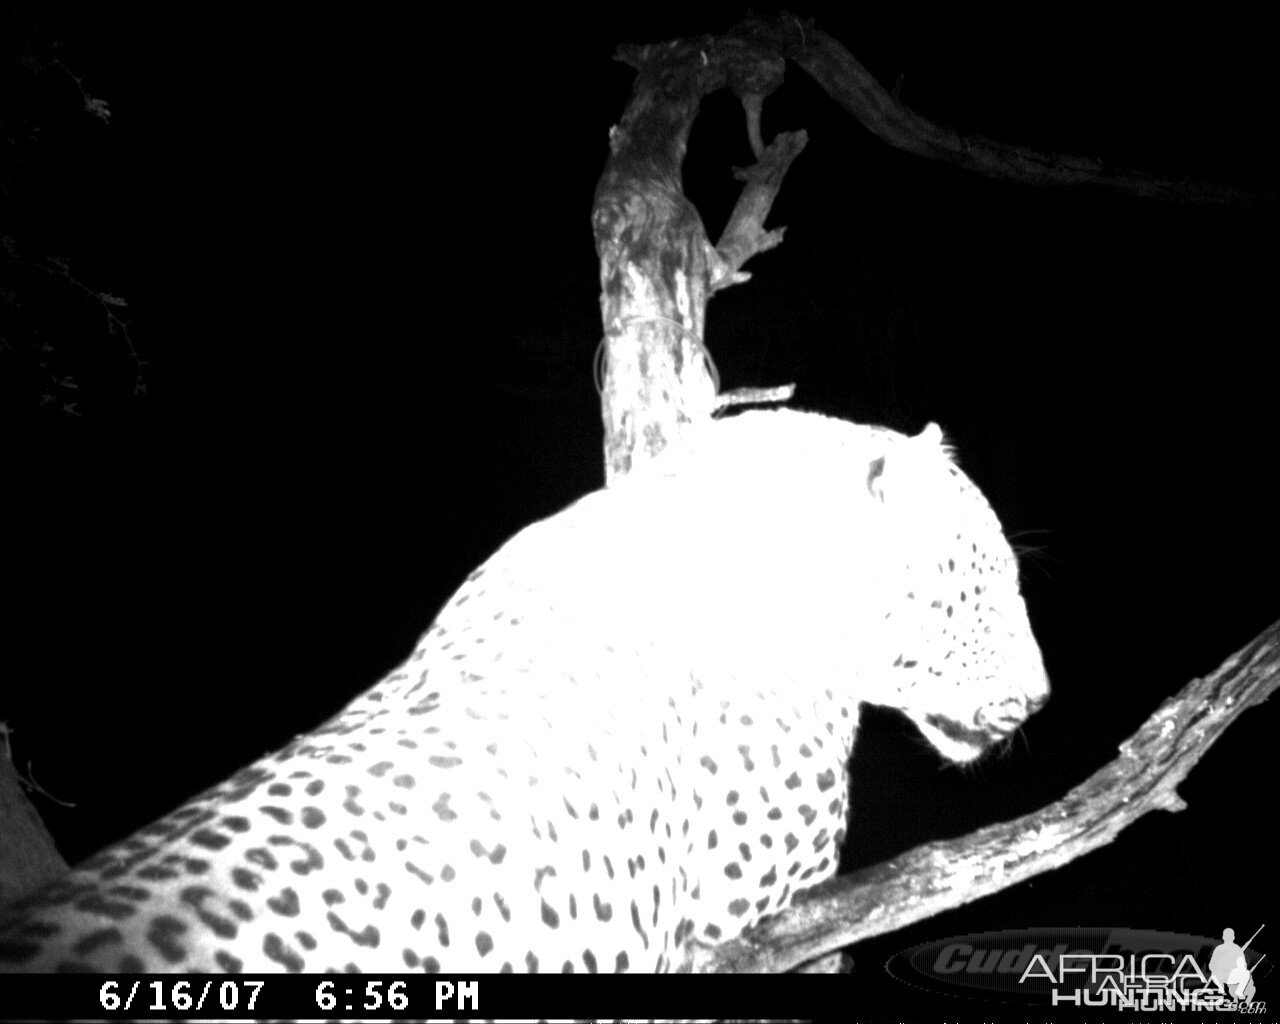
[0,412,1048,973]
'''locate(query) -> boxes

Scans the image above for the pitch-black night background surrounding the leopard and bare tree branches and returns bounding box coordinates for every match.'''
[0,3,1280,1000]
